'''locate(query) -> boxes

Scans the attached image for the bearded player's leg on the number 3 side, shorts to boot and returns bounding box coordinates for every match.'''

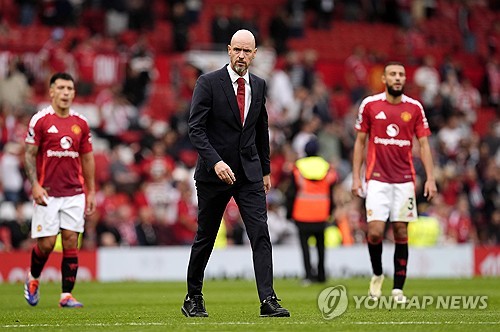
[390,182,417,302]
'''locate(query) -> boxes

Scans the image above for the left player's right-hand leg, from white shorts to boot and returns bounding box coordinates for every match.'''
[59,195,85,308]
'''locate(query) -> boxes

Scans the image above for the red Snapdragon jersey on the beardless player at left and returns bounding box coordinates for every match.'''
[25,106,92,197]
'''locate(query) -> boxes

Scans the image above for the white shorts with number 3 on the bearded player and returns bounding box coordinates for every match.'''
[365,180,418,222]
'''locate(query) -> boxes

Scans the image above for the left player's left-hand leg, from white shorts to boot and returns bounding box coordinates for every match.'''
[24,197,60,306]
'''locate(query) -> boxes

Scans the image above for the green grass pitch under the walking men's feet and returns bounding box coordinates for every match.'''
[0,278,500,332]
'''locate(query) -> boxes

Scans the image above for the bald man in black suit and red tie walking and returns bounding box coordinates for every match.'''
[181,30,290,317]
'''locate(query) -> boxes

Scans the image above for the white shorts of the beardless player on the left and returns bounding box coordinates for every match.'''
[31,194,85,239]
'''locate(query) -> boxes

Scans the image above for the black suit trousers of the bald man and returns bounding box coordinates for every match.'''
[187,179,274,302]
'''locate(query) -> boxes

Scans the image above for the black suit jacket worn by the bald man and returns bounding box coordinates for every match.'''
[189,66,271,183]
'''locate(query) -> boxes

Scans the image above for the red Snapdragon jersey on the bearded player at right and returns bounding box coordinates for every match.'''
[355,92,431,183]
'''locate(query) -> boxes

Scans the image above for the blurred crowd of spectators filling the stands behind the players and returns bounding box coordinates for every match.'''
[0,0,500,251]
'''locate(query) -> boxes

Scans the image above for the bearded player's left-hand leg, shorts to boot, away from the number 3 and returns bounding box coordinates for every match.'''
[365,180,392,300]
